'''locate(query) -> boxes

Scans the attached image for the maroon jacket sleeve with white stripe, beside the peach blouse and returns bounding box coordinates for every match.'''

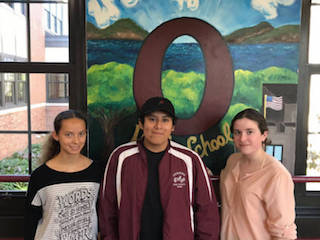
[194,156,220,240]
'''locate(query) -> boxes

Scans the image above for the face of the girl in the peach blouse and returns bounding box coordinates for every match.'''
[233,118,268,155]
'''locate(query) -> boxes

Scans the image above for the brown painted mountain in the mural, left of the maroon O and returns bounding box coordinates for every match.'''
[87,18,148,40]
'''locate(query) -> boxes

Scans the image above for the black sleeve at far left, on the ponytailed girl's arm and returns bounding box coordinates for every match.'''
[24,176,42,240]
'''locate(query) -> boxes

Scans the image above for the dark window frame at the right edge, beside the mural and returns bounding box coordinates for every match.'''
[295,0,320,221]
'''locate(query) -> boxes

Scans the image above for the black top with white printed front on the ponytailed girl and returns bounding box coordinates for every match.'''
[25,161,103,240]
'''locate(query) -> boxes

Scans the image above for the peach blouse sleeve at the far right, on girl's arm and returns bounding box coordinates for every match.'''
[266,170,297,240]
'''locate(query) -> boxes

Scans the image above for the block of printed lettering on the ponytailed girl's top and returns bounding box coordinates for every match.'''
[55,187,95,240]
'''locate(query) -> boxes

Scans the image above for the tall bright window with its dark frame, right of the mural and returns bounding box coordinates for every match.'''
[295,0,320,225]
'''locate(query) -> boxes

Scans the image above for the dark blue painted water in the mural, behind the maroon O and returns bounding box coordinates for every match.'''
[87,40,299,73]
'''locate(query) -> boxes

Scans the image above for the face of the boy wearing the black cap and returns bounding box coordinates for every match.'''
[139,111,174,152]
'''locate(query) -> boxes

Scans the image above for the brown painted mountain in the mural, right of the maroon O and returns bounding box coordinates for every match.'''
[224,22,299,44]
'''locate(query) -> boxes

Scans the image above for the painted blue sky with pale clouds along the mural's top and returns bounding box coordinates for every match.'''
[87,0,301,35]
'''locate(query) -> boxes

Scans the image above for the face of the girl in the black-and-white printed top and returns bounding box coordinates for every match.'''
[52,118,87,155]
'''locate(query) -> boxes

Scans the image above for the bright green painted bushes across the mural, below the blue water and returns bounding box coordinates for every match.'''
[88,62,298,121]
